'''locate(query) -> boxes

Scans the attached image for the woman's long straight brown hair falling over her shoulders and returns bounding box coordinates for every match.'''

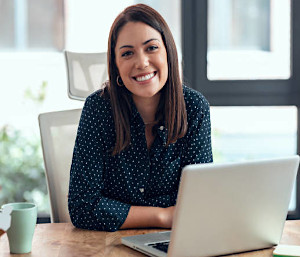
[104,4,187,155]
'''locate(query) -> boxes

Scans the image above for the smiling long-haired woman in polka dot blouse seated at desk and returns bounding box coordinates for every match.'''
[69,4,212,231]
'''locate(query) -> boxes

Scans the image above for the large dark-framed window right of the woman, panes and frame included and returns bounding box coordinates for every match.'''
[182,0,300,218]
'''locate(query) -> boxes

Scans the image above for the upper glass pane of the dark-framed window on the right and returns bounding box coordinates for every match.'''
[207,0,291,80]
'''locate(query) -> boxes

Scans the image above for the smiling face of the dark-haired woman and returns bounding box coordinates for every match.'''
[115,22,168,101]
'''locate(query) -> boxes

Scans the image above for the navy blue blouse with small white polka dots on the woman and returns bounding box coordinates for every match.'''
[68,86,212,231]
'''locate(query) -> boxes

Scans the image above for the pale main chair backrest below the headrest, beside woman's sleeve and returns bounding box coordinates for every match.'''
[39,109,81,223]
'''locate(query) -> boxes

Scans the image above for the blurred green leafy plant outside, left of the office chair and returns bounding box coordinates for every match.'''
[0,82,49,212]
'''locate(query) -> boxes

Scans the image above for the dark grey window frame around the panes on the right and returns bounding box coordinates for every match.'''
[181,0,300,219]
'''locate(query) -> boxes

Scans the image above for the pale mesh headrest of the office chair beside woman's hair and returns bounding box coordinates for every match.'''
[65,51,108,101]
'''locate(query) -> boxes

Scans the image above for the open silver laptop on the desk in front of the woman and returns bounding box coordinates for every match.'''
[122,156,299,257]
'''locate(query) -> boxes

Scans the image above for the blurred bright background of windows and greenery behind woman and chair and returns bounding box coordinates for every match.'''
[0,0,299,218]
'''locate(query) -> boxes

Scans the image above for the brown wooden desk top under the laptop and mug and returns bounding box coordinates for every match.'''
[0,220,300,257]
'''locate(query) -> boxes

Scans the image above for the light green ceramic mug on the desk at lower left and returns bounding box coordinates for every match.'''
[2,203,37,253]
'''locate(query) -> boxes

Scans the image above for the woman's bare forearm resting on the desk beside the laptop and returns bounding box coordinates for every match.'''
[121,206,173,229]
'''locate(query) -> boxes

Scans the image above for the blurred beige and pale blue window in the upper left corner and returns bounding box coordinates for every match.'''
[0,0,64,51]
